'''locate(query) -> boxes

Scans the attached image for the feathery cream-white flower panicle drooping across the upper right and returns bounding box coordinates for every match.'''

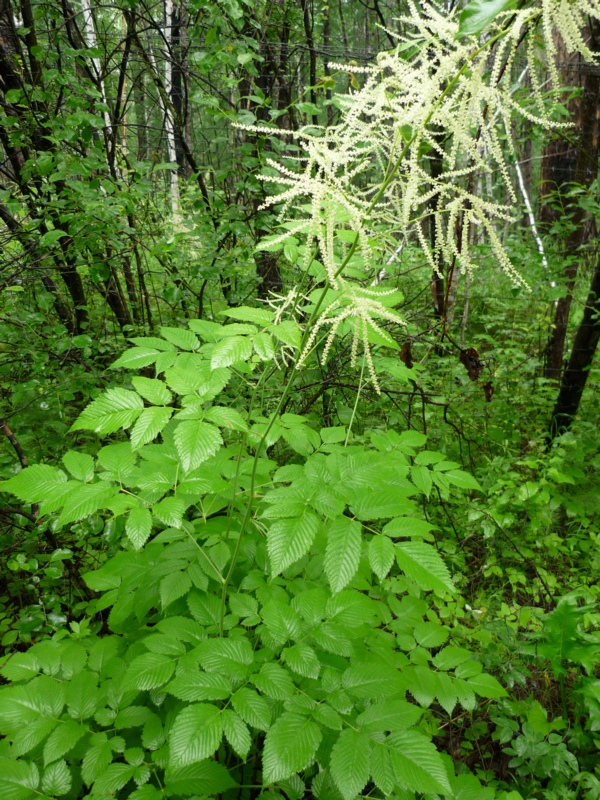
[234,0,600,386]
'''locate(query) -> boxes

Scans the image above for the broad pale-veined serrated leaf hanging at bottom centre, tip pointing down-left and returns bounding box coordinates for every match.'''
[263,712,321,783]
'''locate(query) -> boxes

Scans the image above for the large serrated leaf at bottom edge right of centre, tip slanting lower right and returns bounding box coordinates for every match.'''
[387,729,452,795]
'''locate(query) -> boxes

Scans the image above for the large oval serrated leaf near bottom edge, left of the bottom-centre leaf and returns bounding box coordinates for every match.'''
[169,703,223,767]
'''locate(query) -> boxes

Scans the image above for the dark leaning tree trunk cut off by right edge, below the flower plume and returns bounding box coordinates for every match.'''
[550,256,600,440]
